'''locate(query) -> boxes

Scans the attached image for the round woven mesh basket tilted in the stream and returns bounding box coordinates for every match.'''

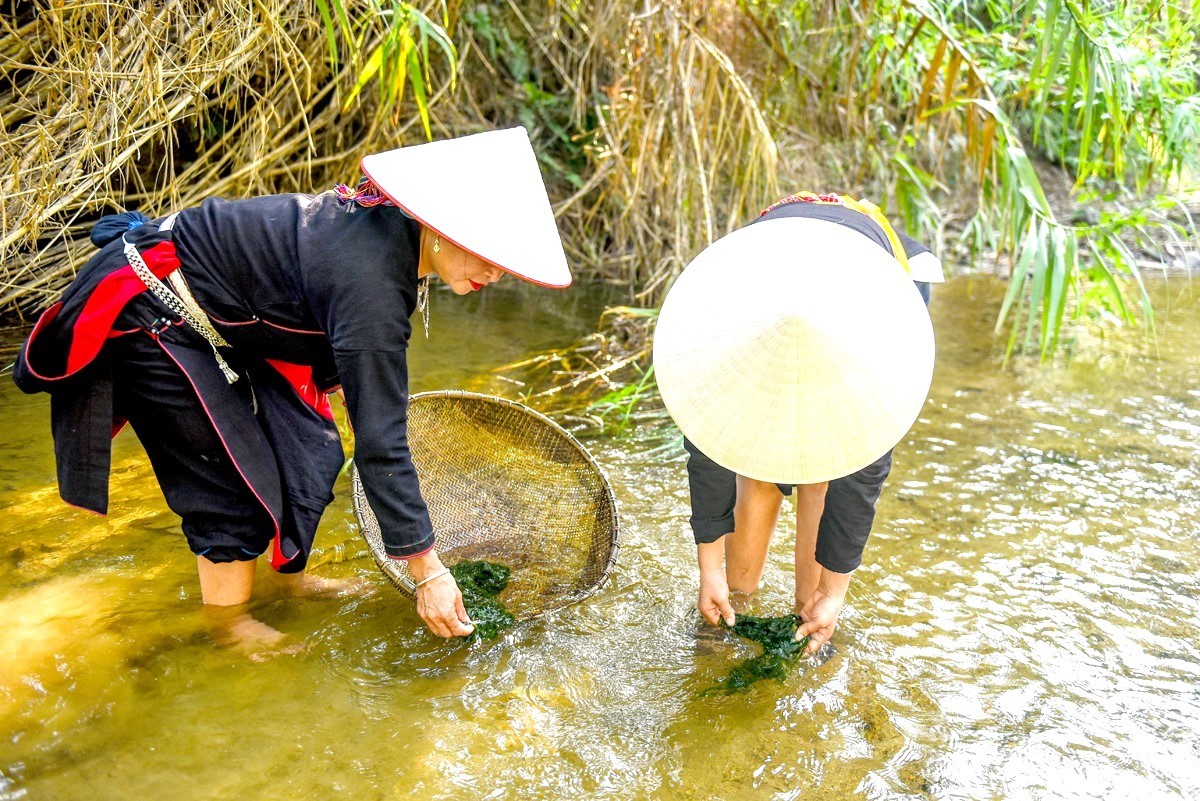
[352,392,618,619]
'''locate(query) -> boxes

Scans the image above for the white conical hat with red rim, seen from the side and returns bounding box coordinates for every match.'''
[362,128,571,288]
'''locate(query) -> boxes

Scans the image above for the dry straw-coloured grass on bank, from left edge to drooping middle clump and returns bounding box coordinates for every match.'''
[0,0,776,320]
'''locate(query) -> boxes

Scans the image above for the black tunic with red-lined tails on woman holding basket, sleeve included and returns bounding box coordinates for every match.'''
[14,193,433,564]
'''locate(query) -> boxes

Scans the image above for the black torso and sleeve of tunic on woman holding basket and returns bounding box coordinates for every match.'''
[175,192,433,556]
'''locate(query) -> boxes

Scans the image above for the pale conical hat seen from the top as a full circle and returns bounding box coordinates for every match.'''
[654,218,934,483]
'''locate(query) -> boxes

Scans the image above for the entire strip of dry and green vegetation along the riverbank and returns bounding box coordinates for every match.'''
[0,0,1200,357]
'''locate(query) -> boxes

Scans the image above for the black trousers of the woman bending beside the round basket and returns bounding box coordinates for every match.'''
[106,294,343,572]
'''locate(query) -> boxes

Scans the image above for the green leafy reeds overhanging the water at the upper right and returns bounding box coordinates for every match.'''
[742,0,1200,357]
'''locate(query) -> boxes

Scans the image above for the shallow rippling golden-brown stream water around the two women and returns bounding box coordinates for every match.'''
[0,273,1200,801]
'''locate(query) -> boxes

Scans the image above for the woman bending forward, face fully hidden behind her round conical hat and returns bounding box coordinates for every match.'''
[654,193,942,654]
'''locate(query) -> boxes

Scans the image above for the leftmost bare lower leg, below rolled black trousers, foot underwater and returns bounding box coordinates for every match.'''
[196,556,302,662]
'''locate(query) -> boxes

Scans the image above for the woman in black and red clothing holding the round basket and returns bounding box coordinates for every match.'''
[14,128,571,648]
